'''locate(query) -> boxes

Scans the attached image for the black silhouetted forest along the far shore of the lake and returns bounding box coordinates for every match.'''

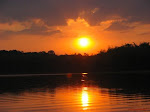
[0,42,150,74]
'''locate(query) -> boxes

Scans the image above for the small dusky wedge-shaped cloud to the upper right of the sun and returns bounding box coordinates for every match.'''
[105,22,134,31]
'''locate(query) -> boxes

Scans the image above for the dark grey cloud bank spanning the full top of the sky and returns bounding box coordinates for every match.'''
[0,0,150,25]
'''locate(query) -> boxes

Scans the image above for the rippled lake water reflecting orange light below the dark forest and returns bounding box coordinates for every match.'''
[0,74,150,112]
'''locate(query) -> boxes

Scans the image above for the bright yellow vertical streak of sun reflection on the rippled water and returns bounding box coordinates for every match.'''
[82,87,89,110]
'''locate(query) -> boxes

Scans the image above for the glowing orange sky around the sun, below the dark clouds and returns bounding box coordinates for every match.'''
[0,17,150,54]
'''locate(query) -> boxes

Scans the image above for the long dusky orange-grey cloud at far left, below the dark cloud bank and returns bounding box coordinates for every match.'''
[0,19,61,38]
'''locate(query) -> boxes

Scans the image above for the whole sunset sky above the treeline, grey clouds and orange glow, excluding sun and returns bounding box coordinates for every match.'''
[0,0,150,54]
